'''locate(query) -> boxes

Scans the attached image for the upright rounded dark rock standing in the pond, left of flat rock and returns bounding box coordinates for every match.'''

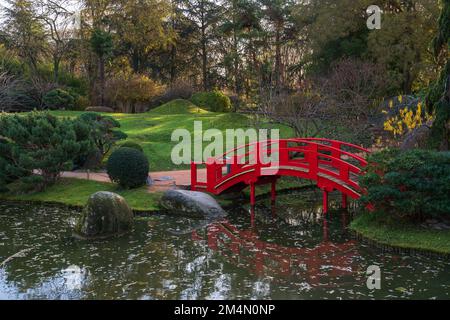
[75,191,133,239]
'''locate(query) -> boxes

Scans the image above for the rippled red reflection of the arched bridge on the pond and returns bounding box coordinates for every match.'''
[192,209,360,286]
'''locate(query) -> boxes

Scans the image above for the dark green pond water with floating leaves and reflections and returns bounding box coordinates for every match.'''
[0,193,450,299]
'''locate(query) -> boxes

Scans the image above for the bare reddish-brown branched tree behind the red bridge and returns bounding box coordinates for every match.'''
[260,59,384,143]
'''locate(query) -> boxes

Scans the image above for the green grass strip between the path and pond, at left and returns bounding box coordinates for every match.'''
[0,179,161,211]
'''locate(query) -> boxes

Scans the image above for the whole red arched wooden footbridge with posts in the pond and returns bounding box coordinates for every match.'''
[191,138,369,213]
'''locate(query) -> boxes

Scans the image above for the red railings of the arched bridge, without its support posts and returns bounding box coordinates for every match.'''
[191,138,368,193]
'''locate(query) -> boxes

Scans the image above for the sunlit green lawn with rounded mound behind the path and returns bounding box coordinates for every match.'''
[52,99,292,171]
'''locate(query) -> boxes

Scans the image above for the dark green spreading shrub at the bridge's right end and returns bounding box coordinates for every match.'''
[360,149,450,219]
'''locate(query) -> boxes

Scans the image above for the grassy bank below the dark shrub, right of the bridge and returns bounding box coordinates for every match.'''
[350,213,450,254]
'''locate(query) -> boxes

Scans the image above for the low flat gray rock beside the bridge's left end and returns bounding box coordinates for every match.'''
[161,190,227,219]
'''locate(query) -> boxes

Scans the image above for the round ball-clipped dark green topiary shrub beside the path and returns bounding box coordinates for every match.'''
[106,147,149,189]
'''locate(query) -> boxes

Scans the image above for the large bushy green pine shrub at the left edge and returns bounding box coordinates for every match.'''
[0,112,94,190]
